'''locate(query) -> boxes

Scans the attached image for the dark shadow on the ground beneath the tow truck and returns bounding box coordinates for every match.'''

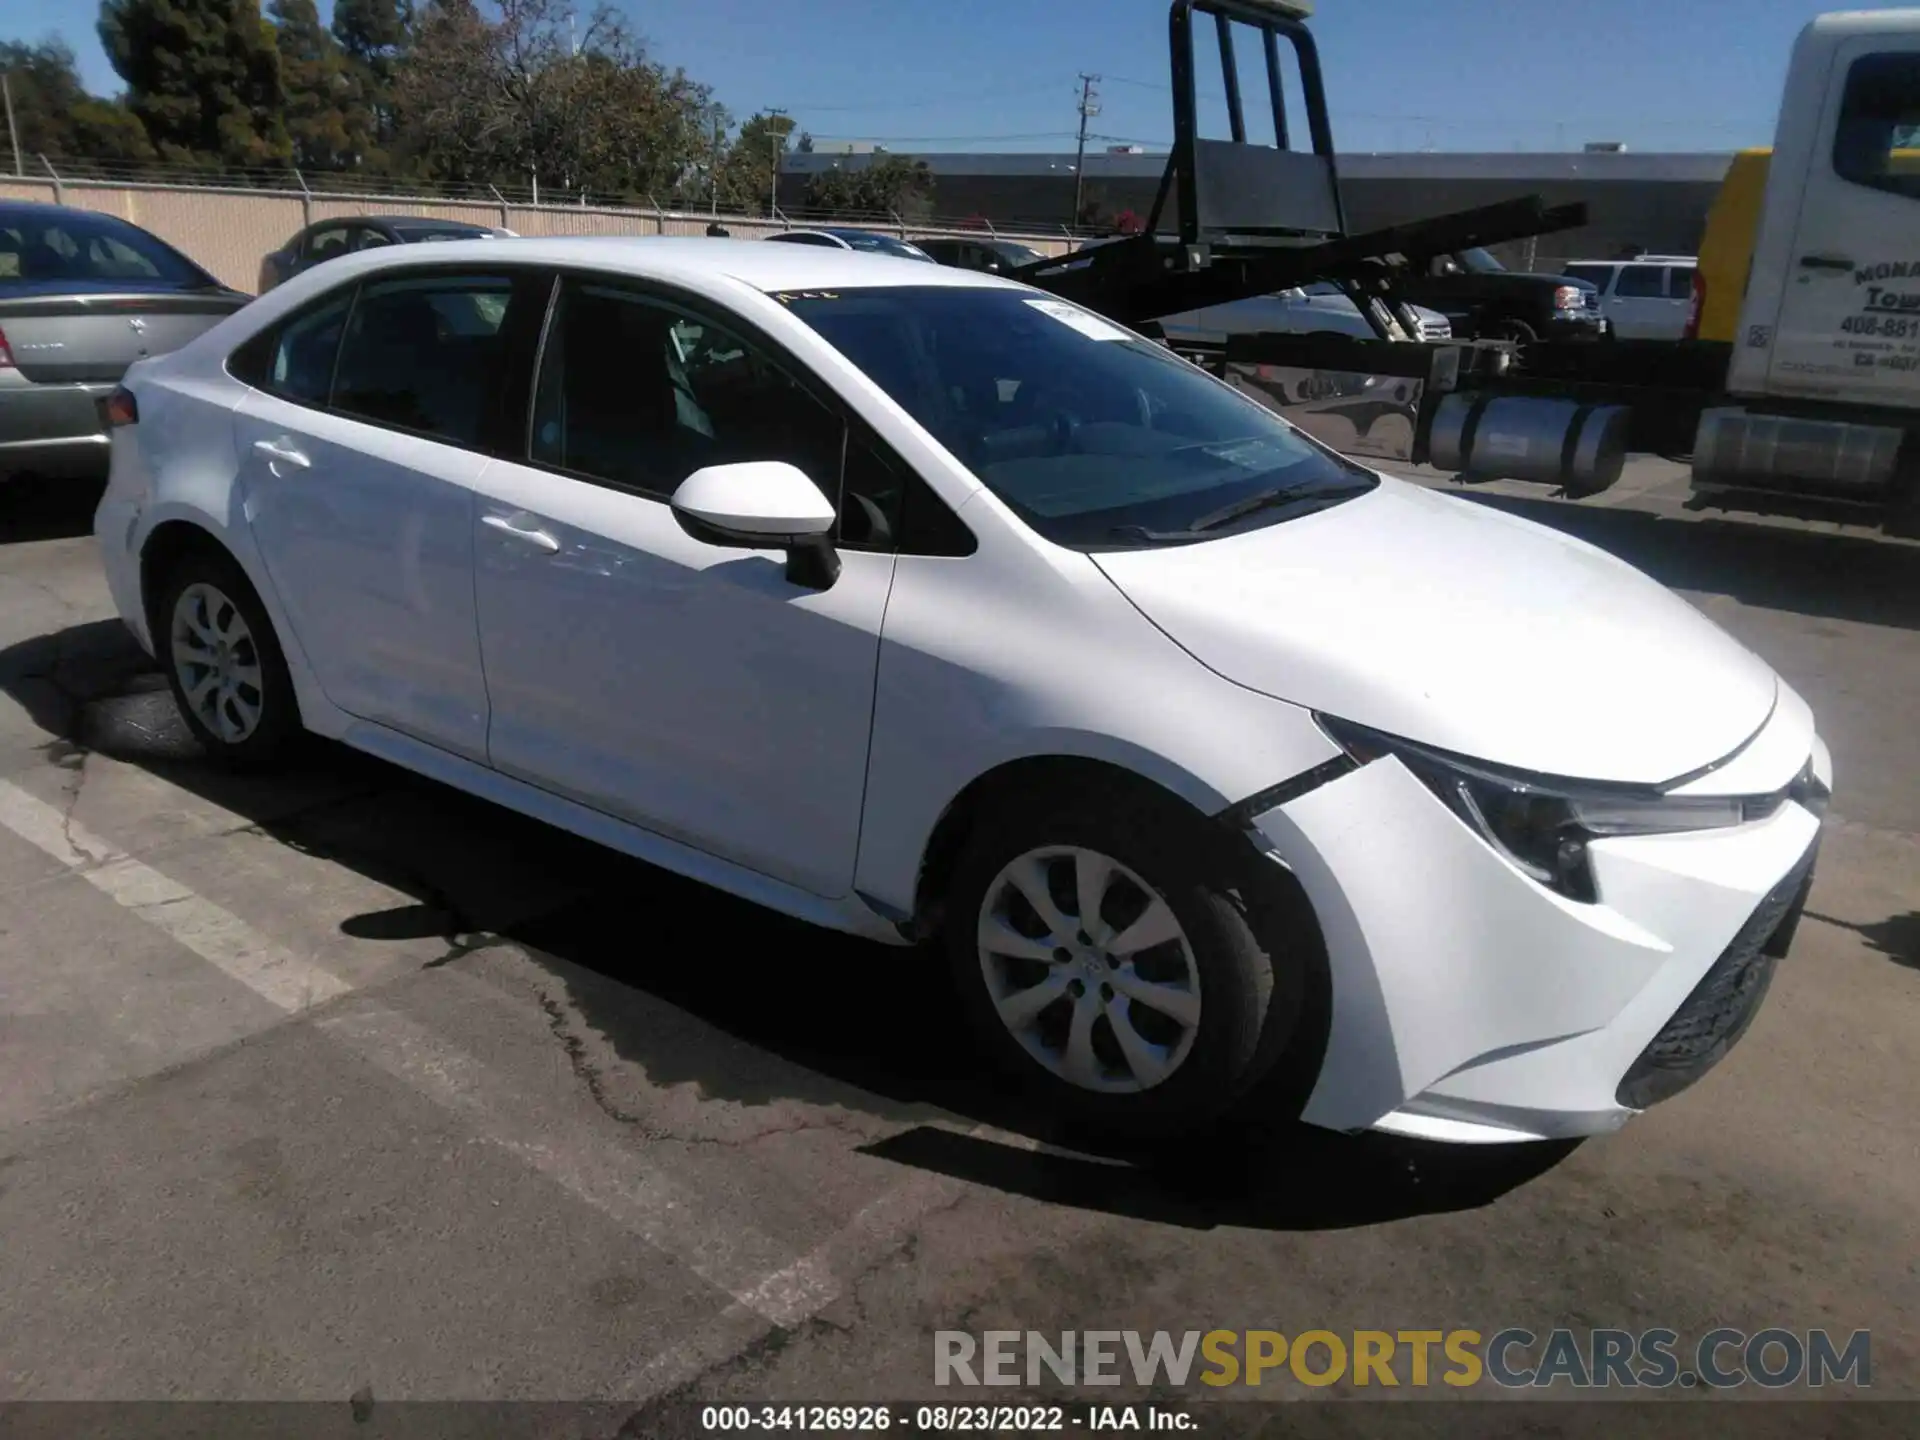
[1446,486,1920,630]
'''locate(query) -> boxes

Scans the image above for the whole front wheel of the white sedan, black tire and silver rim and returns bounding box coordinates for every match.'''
[945,803,1302,1142]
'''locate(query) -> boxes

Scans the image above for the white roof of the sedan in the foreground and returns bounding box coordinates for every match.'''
[291,234,1023,294]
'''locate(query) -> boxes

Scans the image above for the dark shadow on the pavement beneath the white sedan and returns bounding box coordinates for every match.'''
[0,622,1572,1229]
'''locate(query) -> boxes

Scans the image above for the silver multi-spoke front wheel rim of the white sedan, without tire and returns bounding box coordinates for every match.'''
[979,845,1200,1094]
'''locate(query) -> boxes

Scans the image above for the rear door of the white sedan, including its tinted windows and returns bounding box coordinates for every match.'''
[234,273,533,762]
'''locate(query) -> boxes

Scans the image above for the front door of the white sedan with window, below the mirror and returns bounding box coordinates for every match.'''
[474,280,893,895]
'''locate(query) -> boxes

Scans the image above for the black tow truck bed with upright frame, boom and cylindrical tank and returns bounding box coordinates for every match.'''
[1018,0,1758,493]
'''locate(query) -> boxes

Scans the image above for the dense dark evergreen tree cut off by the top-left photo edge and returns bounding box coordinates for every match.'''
[100,0,292,167]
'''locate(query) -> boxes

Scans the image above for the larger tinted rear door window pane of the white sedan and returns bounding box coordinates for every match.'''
[332,275,513,445]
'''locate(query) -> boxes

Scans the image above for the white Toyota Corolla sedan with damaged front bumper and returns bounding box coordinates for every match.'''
[96,240,1832,1140]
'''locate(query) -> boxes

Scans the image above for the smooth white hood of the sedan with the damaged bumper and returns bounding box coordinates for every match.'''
[1092,480,1778,783]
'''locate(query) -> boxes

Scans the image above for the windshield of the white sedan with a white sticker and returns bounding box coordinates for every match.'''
[776,286,1379,549]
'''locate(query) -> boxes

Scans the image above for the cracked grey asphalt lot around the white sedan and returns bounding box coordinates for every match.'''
[0,463,1920,1434]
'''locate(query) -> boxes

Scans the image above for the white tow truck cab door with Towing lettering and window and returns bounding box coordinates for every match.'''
[1766,33,1920,407]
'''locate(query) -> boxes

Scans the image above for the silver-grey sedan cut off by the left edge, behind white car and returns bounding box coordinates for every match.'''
[0,200,248,480]
